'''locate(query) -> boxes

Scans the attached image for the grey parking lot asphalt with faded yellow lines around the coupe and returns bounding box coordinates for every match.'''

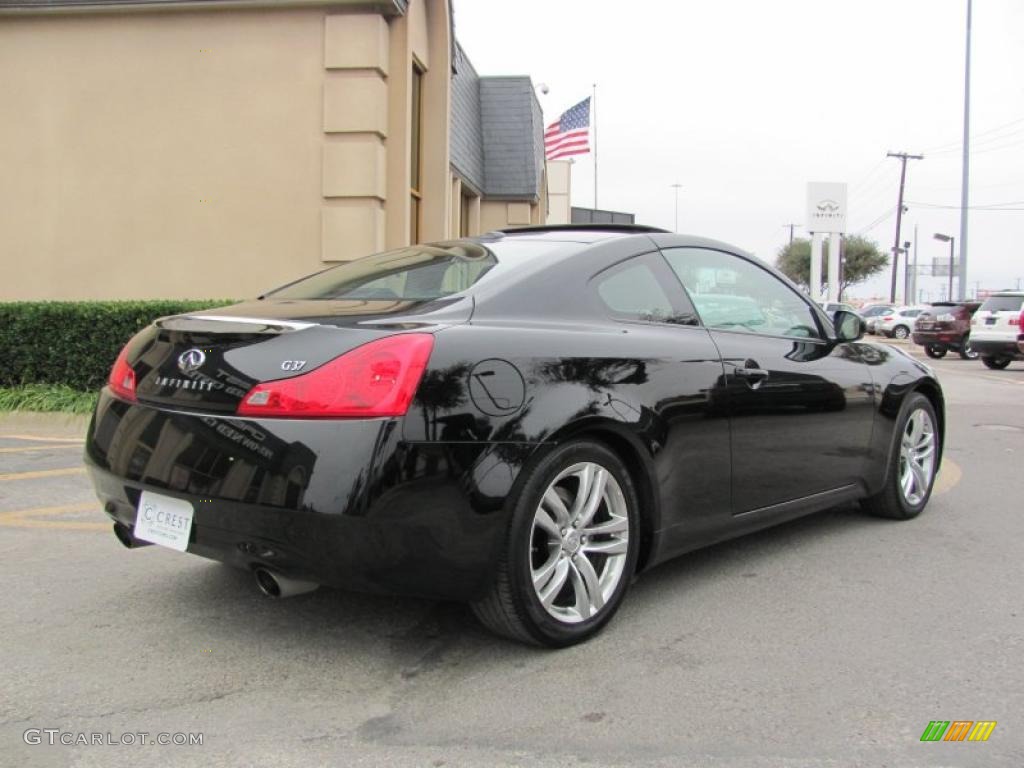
[0,345,1024,768]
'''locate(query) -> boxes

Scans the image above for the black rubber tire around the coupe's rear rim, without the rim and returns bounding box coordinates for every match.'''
[472,440,640,648]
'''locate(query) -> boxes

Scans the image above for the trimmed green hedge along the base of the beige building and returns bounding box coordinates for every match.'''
[0,299,231,391]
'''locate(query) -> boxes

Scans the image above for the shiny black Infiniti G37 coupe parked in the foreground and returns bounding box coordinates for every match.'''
[86,225,944,646]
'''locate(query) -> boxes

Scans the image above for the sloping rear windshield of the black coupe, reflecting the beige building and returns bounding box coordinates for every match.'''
[266,240,566,301]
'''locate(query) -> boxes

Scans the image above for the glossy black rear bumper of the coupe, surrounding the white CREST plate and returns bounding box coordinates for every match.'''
[86,390,515,600]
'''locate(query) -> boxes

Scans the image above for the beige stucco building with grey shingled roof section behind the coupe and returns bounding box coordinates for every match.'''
[0,0,547,301]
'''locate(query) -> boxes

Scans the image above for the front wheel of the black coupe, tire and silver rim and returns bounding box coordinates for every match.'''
[861,392,941,520]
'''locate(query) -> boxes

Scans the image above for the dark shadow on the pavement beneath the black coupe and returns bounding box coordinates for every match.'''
[160,505,887,663]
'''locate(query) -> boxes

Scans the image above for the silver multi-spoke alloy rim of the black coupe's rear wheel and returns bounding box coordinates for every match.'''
[529,462,630,624]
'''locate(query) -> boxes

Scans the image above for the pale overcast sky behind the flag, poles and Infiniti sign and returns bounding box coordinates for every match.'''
[455,0,1024,299]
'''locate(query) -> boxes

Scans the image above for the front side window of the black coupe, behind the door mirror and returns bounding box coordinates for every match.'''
[663,248,821,338]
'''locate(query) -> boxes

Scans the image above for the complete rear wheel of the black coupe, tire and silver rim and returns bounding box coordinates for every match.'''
[473,440,639,647]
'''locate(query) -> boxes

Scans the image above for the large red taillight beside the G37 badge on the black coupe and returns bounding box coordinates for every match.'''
[238,334,434,419]
